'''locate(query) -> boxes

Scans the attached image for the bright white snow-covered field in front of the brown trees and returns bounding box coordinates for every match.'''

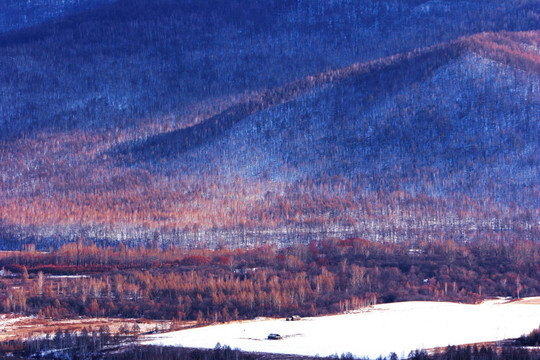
[143,298,540,358]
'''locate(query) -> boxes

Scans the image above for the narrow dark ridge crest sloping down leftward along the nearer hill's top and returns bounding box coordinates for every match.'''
[112,31,540,165]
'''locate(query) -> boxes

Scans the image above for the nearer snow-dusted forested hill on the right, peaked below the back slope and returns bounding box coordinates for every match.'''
[108,32,540,245]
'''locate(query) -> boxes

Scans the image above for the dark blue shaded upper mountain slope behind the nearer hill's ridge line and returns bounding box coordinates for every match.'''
[0,0,540,138]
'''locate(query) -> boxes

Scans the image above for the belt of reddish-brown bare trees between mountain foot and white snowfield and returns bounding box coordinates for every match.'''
[0,239,540,324]
